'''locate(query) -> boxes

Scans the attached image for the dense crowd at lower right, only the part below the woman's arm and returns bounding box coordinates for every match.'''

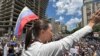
[64,38,100,56]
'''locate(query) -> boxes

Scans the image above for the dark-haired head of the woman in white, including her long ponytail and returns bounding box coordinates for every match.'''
[25,19,53,49]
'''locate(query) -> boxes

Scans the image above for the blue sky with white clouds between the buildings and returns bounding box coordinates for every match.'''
[46,0,83,31]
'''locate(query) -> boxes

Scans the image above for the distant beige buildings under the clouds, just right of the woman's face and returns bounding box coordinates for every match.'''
[49,18,67,35]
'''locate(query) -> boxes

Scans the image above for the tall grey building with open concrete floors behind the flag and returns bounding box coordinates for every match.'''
[0,0,49,33]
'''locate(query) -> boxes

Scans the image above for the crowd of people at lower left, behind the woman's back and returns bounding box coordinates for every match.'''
[0,37,23,56]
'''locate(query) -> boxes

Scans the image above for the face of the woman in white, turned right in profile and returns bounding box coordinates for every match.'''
[43,24,53,42]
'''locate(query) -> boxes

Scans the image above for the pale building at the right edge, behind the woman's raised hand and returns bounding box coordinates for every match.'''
[82,0,100,26]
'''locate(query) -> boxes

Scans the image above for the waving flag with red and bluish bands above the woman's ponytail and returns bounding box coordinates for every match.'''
[14,7,38,36]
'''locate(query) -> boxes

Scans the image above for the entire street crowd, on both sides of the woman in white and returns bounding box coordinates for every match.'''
[0,34,100,56]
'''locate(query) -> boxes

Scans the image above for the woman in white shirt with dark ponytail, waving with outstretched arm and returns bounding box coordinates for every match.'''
[22,10,100,56]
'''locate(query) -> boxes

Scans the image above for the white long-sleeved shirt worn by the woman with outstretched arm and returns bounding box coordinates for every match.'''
[22,25,92,56]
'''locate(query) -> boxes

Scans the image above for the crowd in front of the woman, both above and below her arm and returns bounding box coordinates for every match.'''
[53,32,100,56]
